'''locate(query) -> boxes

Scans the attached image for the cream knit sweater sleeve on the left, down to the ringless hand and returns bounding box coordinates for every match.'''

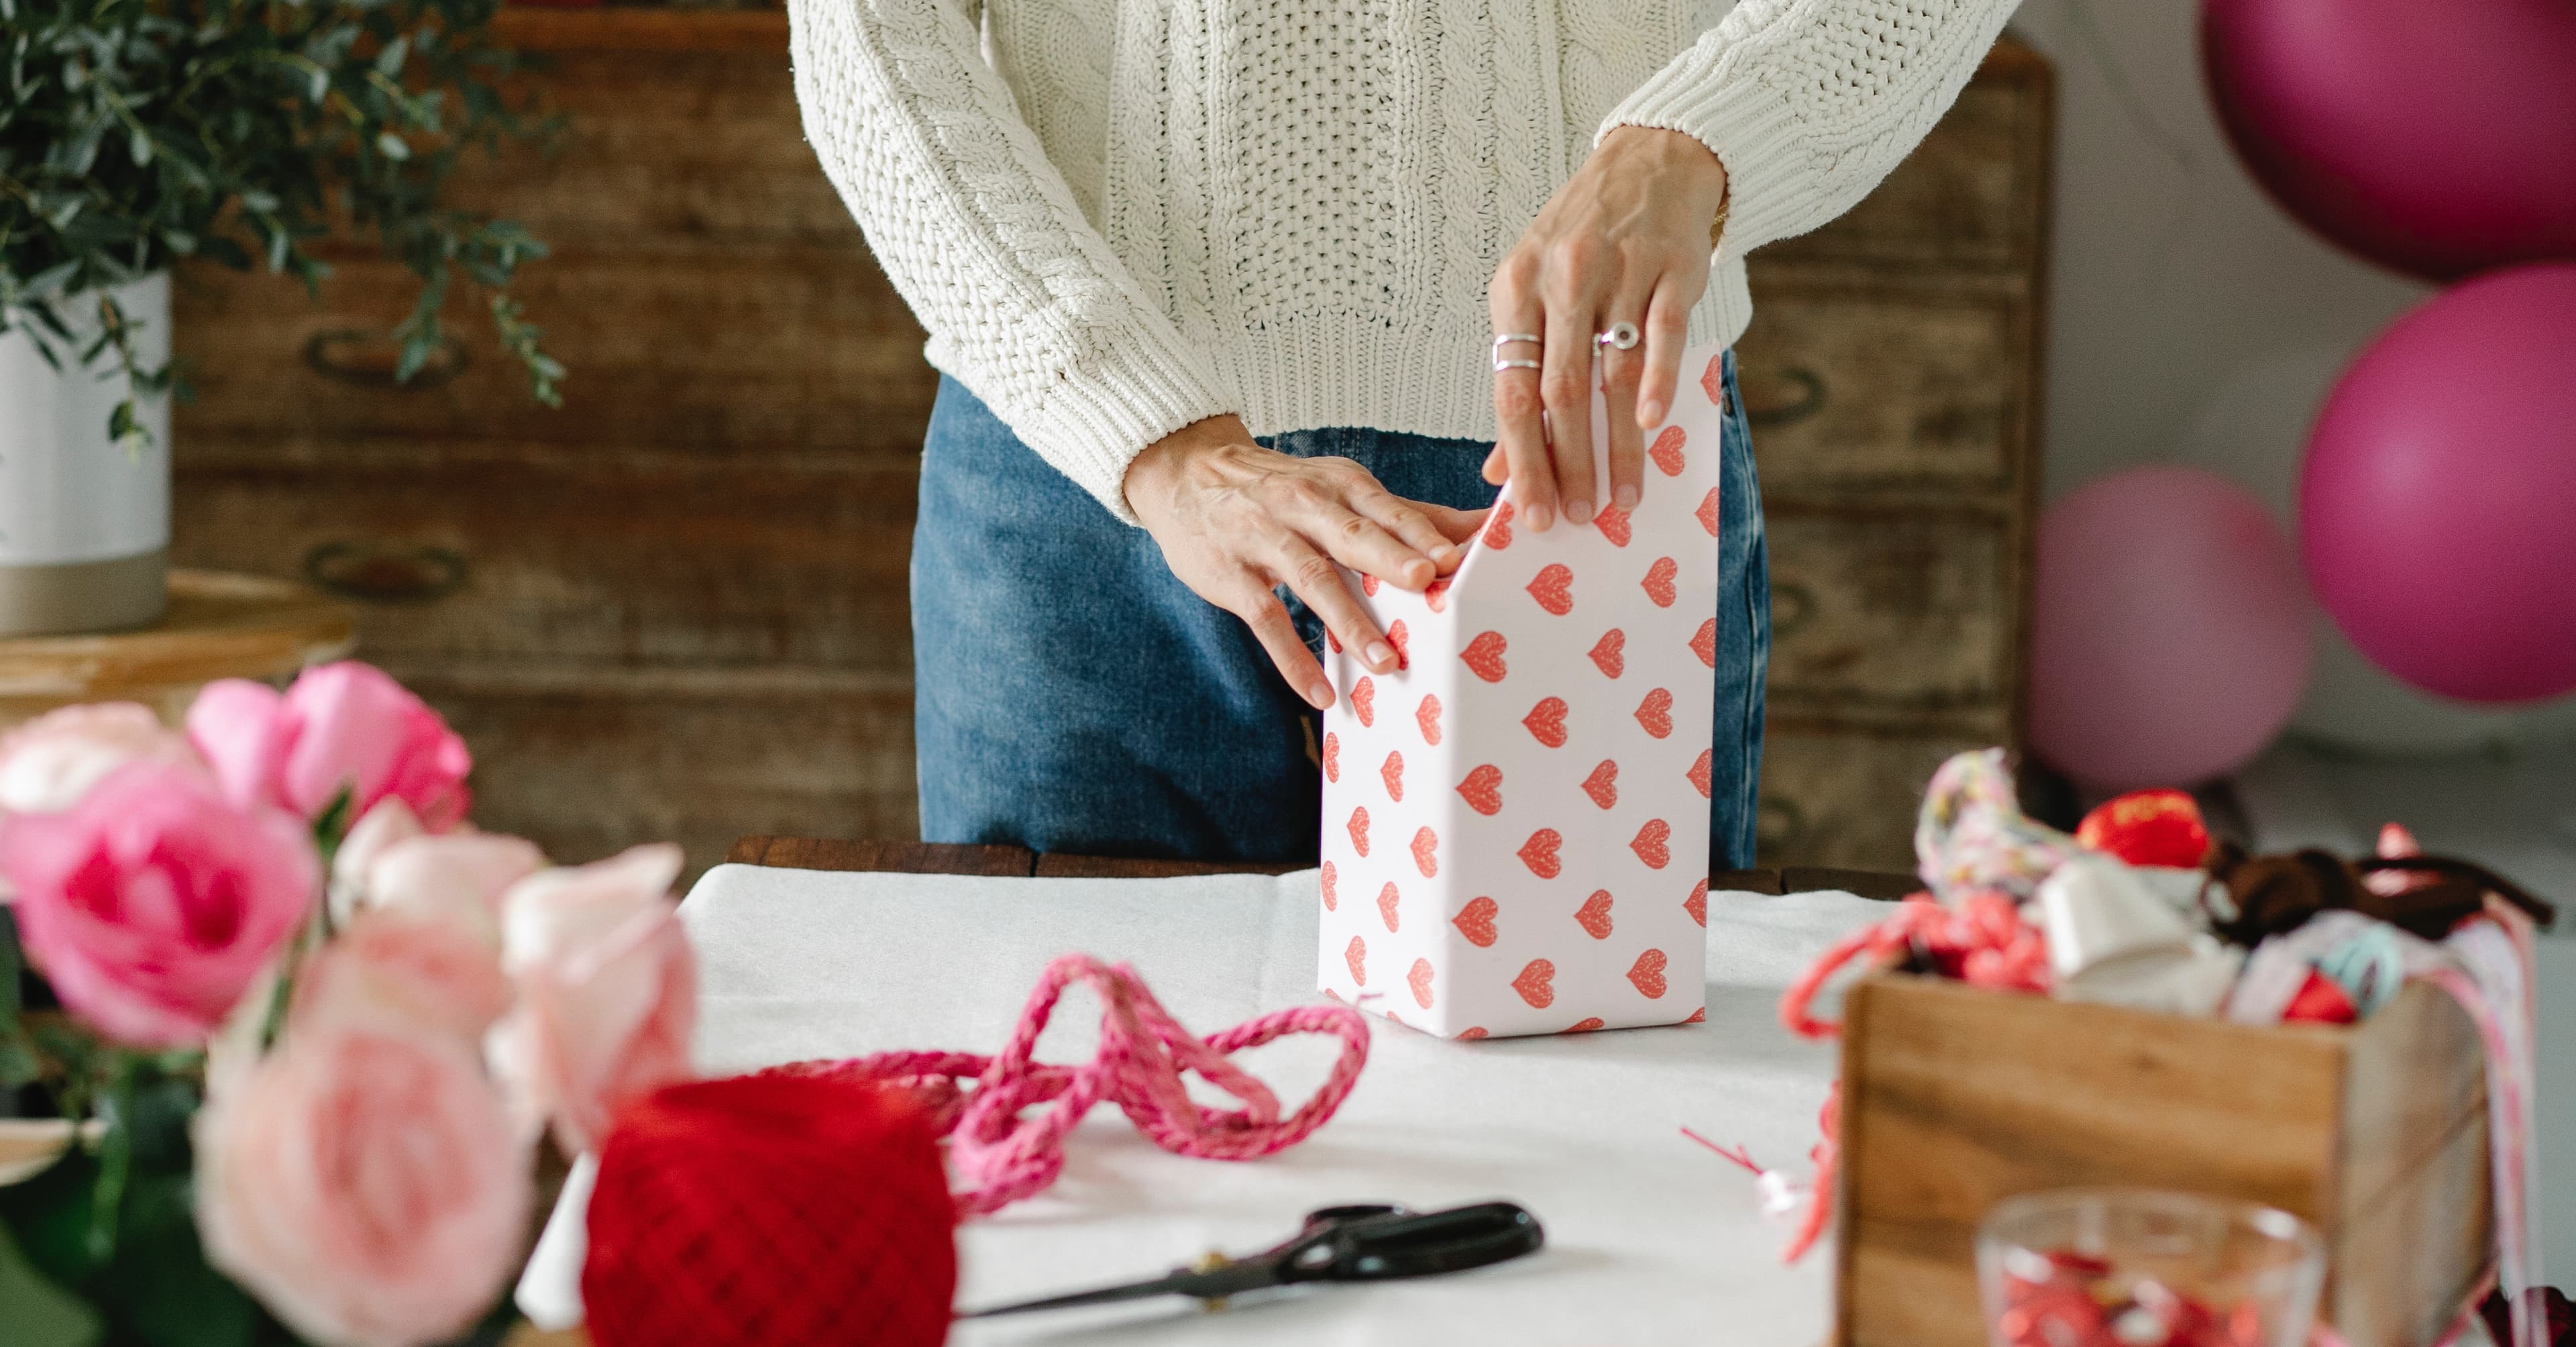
[788,0,1236,523]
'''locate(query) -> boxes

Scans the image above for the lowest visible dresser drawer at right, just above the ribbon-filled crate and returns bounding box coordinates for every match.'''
[1754,714,2004,871]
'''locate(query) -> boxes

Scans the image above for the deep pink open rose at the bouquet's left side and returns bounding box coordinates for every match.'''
[0,762,322,1046]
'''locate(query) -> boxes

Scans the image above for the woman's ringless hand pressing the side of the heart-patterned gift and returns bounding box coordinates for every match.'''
[1126,415,1484,708]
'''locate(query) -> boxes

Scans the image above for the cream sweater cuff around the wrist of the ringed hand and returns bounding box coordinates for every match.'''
[1595,49,1824,258]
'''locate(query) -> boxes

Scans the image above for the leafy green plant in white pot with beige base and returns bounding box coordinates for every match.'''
[0,0,561,636]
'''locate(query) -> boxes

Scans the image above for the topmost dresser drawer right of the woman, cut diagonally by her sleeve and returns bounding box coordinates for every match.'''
[1754,41,2051,270]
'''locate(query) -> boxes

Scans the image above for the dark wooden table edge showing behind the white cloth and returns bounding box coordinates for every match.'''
[724,837,1922,899]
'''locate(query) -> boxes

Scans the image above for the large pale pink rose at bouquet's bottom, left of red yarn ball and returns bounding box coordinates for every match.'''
[196,1012,531,1347]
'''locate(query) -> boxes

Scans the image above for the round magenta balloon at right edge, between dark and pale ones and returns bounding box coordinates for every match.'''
[2298,266,2576,700]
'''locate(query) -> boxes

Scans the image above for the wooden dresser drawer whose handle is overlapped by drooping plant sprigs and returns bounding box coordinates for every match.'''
[175,248,938,466]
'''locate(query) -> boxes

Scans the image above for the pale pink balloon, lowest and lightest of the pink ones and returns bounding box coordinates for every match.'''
[2030,466,2310,791]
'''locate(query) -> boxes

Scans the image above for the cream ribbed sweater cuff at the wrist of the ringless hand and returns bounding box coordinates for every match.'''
[1012,314,1242,523]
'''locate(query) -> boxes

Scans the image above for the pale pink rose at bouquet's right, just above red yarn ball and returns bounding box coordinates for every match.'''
[494,842,698,1154]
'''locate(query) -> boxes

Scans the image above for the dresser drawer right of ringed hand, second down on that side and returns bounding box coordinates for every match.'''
[1736,282,2033,494]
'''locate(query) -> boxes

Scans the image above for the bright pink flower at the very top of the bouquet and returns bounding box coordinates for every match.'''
[188,659,474,832]
